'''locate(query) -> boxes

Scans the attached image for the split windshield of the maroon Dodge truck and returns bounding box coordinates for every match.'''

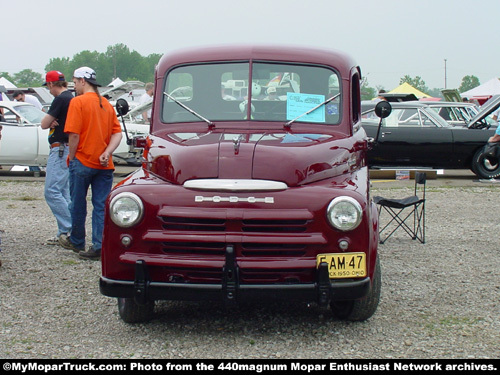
[162,62,341,125]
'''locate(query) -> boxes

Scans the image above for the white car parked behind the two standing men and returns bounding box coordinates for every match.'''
[0,101,148,167]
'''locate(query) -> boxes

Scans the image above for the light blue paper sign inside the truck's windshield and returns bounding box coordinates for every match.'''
[286,92,325,122]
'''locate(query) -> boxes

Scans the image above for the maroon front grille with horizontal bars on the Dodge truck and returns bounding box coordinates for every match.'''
[159,207,325,259]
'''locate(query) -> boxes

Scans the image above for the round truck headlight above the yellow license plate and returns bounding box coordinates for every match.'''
[326,197,362,231]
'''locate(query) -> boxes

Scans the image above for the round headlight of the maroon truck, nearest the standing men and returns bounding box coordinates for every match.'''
[109,193,144,228]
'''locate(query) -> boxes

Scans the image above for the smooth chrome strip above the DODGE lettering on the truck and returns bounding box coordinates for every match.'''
[183,178,288,191]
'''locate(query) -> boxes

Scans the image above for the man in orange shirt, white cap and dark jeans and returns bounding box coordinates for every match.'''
[59,67,122,260]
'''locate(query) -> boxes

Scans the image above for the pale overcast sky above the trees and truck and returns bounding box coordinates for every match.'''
[0,0,500,90]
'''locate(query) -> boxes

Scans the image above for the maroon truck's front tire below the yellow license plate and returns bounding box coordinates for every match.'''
[330,258,381,321]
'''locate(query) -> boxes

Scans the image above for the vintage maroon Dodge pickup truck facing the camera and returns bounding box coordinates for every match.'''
[100,47,381,322]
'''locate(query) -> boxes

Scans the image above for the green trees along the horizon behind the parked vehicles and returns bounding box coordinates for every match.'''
[0,43,480,100]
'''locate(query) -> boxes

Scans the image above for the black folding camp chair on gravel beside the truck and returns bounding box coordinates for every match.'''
[373,172,427,244]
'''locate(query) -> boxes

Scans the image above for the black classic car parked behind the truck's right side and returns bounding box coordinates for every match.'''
[362,98,500,178]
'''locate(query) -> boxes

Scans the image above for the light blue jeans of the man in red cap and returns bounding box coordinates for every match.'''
[44,146,71,236]
